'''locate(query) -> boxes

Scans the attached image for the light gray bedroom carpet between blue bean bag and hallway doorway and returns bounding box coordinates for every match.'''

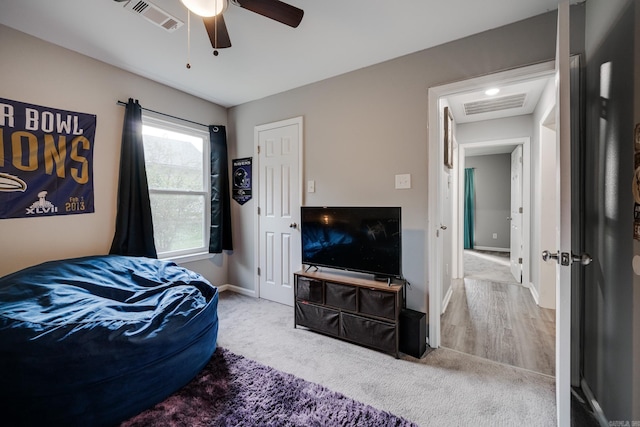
[212,291,556,427]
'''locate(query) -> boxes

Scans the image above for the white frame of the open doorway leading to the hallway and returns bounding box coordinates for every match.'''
[427,61,555,348]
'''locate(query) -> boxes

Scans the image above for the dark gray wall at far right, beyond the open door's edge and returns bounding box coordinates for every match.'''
[583,0,640,422]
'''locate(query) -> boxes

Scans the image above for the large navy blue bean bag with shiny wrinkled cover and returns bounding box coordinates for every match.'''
[0,255,218,426]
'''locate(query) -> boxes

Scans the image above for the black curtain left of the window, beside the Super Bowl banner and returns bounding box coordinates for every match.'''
[109,98,158,258]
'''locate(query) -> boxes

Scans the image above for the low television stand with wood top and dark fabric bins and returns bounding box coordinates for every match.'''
[294,271,403,358]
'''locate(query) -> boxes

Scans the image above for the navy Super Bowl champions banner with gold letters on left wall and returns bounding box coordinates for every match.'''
[0,98,96,219]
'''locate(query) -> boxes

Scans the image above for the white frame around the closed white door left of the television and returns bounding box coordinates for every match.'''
[252,116,305,298]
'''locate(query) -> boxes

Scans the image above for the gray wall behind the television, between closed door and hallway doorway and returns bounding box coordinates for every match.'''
[229,8,583,311]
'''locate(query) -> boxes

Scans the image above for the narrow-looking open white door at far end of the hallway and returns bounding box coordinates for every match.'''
[509,145,523,283]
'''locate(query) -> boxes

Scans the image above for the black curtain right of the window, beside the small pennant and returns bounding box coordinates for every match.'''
[209,126,233,254]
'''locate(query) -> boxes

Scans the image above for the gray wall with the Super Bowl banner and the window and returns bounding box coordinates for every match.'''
[0,25,227,284]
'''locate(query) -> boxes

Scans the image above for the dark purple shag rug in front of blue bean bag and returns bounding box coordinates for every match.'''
[121,348,415,427]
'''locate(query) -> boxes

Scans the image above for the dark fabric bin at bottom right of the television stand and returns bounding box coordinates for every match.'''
[340,313,396,353]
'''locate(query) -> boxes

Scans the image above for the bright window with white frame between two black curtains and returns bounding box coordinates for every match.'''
[142,116,211,258]
